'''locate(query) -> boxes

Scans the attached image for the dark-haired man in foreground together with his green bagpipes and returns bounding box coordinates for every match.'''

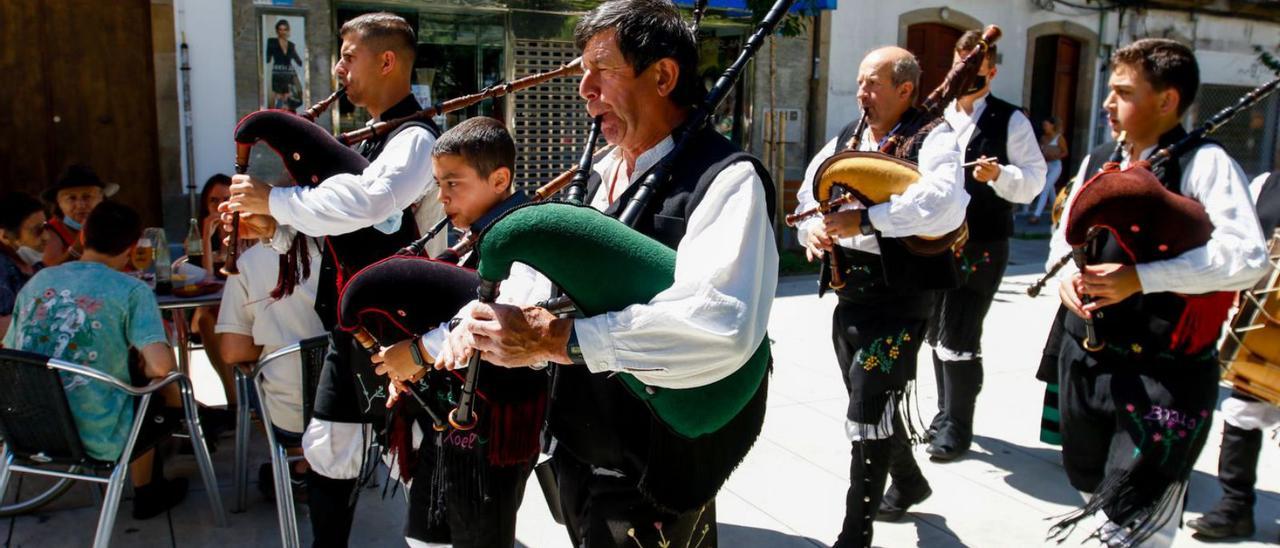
[407,0,786,547]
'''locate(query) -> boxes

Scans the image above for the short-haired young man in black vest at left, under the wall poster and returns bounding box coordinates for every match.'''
[221,13,439,547]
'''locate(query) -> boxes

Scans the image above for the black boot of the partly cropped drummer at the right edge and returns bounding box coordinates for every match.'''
[1187,424,1262,540]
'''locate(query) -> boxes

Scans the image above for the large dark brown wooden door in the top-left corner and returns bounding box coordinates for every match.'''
[0,0,161,225]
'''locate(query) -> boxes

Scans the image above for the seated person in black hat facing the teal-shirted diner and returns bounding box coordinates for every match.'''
[41,165,120,266]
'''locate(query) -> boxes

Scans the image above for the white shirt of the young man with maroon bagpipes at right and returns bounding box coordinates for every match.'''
[1046,145,1267,294]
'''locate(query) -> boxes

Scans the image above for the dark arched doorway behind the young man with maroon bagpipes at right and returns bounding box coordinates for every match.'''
[1027,35,1087,184]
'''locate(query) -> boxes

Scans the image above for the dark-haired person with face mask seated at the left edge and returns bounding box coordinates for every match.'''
[0,192,47,338]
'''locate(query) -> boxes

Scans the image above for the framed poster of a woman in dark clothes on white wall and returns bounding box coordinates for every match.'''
[261,13,308,111]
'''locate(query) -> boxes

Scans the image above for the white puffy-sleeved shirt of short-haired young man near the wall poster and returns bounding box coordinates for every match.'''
[268,119,447,256]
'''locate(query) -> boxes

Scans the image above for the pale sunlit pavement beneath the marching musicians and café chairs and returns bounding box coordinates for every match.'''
[0,239,1280,548]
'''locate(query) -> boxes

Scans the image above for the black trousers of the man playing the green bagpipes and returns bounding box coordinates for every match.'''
[552,448,717,548]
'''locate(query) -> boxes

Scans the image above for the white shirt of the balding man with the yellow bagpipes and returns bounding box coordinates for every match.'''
[796,117,969,255]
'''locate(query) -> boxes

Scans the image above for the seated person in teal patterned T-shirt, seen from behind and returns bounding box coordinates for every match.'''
[4,202,187,520]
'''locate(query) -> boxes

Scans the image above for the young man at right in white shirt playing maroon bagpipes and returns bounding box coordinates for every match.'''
[1050,38,1266,545]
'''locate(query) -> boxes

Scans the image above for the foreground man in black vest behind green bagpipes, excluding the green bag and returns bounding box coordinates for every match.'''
[438,0,778,547]
